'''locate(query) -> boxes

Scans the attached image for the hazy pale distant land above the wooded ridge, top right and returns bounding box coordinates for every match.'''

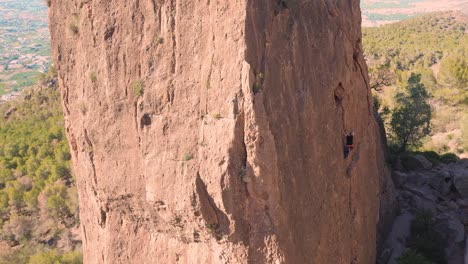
[361,0,468,27]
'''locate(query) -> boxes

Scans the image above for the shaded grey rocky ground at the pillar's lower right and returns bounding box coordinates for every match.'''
[379,160,468,264]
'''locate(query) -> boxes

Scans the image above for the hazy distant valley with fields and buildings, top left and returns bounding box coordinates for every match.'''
[0,0,51,97]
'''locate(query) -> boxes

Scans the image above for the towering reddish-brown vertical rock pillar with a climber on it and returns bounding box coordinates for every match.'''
[49,0,392,263]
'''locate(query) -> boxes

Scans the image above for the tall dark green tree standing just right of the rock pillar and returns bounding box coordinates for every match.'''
[390,74,432,152]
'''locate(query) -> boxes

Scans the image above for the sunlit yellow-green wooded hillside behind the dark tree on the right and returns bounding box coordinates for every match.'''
[363,13,468,157]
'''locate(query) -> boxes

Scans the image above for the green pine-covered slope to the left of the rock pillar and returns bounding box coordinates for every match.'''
[0,70,81,263]
